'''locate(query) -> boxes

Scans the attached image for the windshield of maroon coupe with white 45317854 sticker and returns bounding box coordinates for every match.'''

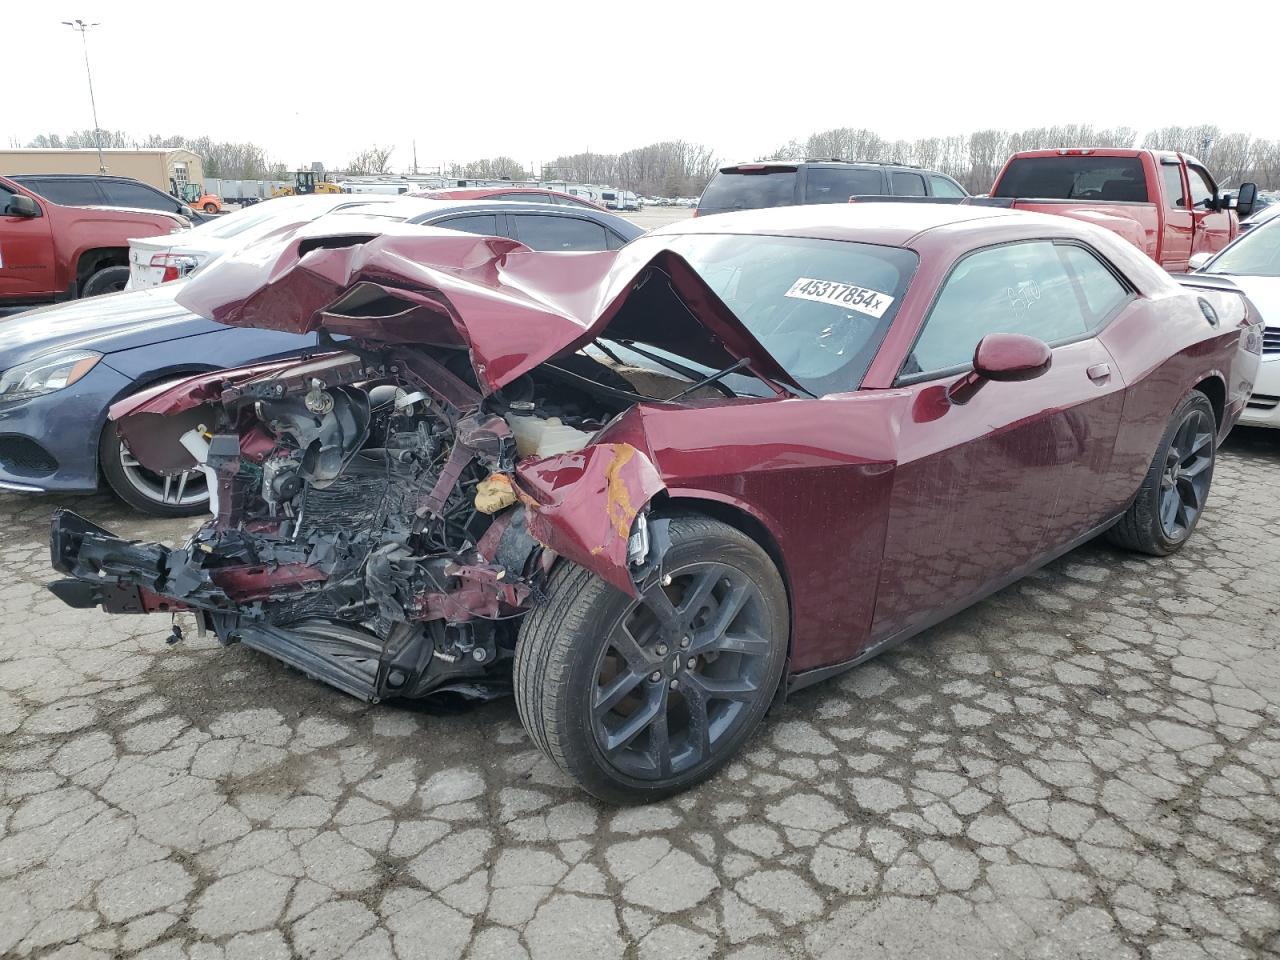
[614,234,919,396]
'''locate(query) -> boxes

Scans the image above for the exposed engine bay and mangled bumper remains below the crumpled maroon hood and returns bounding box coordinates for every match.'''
[52,349,708,700]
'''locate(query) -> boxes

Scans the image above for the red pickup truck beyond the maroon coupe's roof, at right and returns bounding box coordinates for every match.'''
[979,148,1257,273]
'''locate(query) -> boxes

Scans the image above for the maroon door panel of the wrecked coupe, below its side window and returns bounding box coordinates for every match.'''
[873,350,1123,640]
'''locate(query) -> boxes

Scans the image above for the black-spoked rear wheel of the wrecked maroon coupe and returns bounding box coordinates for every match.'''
[1107,390,1217,557]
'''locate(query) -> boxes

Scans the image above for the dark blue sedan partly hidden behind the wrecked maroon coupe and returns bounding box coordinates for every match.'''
[0,197,643,516]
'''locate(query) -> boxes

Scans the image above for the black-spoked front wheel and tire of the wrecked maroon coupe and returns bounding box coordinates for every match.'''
[515,516,790,804]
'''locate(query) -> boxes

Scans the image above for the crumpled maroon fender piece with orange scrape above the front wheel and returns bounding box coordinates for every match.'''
[516,443,666,596]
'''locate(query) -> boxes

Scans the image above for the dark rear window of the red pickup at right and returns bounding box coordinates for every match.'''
[991,156,1147,204]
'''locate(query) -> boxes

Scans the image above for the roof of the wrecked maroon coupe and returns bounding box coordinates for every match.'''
[652,202,1018,247]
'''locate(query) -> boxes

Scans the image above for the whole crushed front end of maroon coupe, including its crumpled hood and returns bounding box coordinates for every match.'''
[50,223,803,700]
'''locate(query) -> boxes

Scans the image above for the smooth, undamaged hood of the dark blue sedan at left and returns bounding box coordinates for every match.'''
[0,280,225,370]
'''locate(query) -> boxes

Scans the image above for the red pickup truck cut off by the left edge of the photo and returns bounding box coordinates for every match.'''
[0,177,191,308]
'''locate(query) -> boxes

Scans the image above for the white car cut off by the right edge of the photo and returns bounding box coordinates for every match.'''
[1192,216,1280,428]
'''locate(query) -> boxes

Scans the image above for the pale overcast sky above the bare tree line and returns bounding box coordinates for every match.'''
[0,0,1280,169]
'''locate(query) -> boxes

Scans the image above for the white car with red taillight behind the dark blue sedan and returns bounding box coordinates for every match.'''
[124,193,397,291]
